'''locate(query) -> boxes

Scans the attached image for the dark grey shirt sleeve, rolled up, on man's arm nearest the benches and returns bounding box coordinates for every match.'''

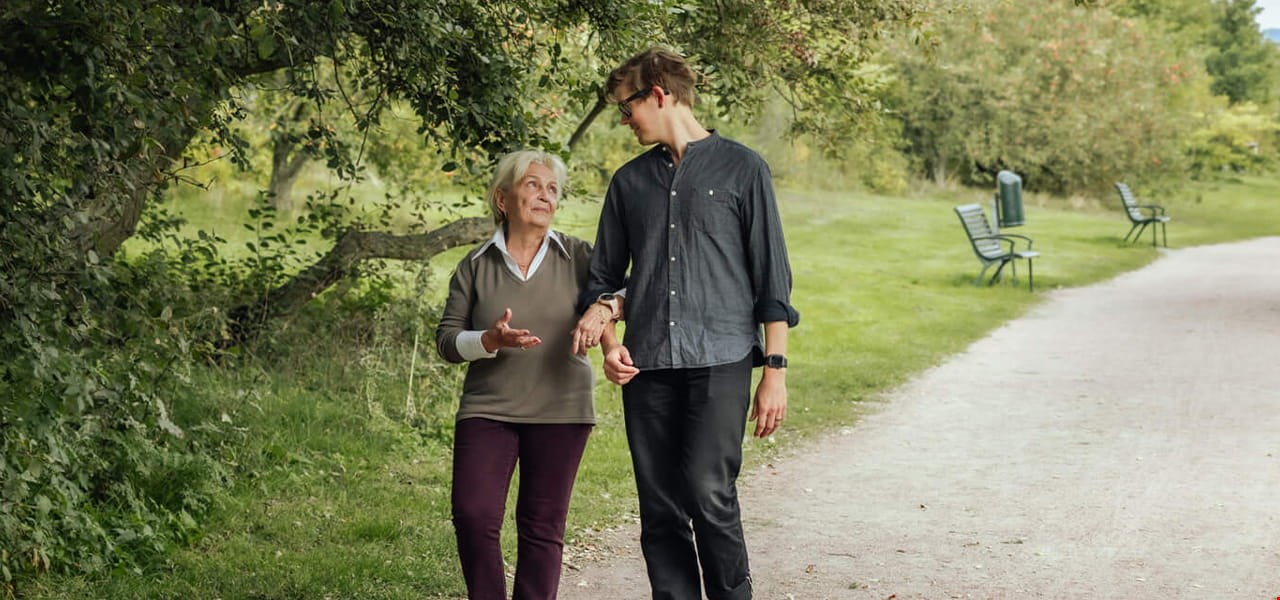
[744,162,800,328]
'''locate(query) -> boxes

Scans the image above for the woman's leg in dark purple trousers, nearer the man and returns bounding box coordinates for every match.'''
[512,423,591,600]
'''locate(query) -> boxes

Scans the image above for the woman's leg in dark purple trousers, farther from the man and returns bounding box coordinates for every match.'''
[452,418,517,600]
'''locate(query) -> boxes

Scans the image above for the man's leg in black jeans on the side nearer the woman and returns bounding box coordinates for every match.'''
[622,370,701,600]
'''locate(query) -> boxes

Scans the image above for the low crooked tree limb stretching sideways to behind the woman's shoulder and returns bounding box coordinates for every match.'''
[225,216,493,348]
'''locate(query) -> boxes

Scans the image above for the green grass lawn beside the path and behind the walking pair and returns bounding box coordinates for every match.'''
[22,172,1280,599]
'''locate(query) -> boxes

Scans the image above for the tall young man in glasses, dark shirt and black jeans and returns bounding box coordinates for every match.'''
[579,49,800,600]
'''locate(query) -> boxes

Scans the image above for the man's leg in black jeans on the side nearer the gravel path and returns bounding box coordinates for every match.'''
[684,357,751,600]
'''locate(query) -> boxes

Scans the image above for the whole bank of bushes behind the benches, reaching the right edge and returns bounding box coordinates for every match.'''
[887,0,1280,194]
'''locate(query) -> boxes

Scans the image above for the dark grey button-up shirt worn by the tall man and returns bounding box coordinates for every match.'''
[580,132,800,370]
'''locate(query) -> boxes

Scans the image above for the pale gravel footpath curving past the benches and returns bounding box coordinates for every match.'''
[561,238,1280,600]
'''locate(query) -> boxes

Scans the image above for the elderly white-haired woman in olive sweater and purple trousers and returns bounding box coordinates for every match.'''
[435,150,618,600]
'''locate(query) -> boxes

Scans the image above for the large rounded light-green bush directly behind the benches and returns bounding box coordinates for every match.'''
[891,0,1207,193]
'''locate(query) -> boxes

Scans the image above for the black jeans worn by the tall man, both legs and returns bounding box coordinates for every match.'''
[622,356,751,600]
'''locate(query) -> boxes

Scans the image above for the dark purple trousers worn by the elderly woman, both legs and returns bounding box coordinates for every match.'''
[453,418,591,600]
